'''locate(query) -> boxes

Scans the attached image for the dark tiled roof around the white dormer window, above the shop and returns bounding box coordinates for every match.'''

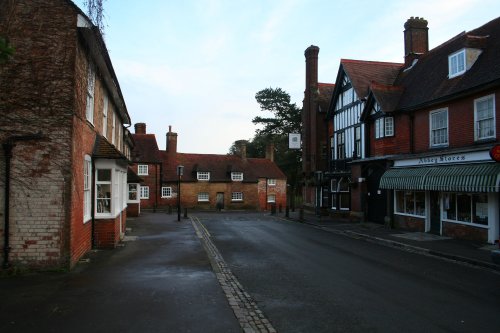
[395,18,500,110]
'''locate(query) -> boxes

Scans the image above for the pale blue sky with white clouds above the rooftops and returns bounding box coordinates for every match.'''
[75,0,500,154]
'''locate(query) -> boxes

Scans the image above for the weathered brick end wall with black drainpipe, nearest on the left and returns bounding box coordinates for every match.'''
[0,0,77,267]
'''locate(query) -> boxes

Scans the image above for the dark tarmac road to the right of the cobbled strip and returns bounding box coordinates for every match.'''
[197,213,500,333]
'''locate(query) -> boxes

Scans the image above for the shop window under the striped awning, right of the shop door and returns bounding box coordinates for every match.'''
[443,193,488,225]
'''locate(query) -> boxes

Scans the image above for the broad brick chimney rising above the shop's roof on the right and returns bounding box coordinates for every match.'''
[404,16,429,67]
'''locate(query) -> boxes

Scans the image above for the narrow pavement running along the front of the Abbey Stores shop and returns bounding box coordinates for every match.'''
[282,209,500,273]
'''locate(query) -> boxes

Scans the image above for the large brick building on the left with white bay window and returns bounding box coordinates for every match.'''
[0,0,131,268]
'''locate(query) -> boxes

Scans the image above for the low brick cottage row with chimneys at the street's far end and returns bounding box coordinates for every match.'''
[132,123,287,210]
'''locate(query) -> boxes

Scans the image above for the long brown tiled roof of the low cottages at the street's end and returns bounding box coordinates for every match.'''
[161,152,286,182]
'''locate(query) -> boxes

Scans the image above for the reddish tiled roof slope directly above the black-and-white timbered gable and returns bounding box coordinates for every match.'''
[340,59,403,98]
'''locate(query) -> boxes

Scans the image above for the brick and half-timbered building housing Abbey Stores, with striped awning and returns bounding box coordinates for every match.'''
[316,17,500,243]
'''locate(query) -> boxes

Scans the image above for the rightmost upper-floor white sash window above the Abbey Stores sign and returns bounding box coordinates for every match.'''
[474,95,496,140]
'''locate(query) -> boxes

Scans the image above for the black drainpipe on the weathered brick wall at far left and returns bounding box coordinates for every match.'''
[2,132,42,269]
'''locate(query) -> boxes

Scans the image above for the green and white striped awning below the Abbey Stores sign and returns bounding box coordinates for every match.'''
[379,163,500,192]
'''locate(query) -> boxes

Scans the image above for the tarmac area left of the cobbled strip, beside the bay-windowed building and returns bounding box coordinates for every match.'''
[0,213,241,333]
